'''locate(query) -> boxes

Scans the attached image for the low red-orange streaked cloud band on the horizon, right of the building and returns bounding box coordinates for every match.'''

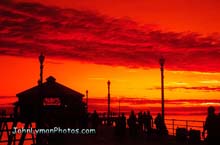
[89,97,220,115]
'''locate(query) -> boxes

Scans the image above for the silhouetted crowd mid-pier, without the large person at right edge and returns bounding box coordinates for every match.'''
[90,110,168,138]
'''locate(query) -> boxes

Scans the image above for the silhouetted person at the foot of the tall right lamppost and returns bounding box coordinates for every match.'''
[154,113,166,135]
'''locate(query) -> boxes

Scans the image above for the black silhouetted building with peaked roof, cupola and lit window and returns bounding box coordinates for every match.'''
[16,76,86,122]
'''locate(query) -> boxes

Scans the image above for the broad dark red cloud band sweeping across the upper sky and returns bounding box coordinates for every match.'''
[0,2,220,72]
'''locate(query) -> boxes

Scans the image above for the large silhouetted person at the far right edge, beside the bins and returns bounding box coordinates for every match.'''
[203,106,220,145]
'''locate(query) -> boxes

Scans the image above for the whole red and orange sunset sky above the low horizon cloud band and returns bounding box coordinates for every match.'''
[0,0,220,109]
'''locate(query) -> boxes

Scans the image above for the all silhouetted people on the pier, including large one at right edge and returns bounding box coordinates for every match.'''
[82,106,220,145]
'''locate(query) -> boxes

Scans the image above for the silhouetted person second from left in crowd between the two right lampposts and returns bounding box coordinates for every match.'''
[128,110,137,137]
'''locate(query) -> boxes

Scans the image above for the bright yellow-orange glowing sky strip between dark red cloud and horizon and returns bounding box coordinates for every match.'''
[0,56,220,105]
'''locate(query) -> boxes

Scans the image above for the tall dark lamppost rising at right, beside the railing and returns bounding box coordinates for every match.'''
[160,58,165,121]
